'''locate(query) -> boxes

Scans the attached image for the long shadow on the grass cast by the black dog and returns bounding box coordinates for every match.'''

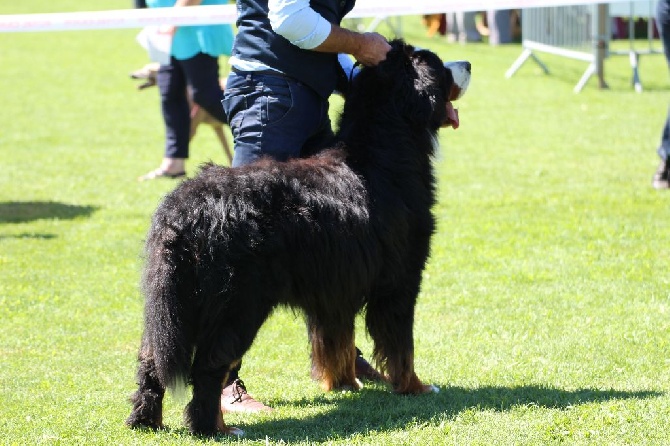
[230,386,662,443]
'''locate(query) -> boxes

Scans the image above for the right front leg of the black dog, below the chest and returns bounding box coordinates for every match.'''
[365,298,438,394]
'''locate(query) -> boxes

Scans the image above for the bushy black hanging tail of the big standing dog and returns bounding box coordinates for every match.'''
[142,222,194,394]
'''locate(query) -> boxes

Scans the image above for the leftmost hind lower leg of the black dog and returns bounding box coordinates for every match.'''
[126,341,165,429]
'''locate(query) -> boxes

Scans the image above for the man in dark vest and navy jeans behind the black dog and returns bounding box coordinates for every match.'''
[221,0,391,412]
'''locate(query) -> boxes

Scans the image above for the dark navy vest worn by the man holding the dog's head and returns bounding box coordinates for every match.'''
[233,0,355,98]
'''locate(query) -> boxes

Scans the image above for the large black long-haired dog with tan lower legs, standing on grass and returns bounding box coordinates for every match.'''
[126,40,470,435]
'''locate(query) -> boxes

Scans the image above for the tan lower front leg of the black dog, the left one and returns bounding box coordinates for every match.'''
[307,318,363,391]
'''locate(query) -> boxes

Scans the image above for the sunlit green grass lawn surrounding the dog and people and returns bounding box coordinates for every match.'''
[0,0,670,445]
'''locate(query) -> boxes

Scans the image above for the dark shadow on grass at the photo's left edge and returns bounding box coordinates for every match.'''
[0,201,98,225]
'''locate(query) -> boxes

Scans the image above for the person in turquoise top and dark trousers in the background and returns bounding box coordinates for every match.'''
[139,0,233,181]
